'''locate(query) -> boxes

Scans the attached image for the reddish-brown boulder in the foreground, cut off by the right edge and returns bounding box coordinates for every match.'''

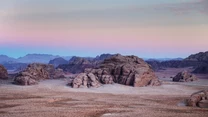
[187,90,208,108]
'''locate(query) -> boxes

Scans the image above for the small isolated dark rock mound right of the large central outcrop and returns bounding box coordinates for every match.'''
[173,71,198,82]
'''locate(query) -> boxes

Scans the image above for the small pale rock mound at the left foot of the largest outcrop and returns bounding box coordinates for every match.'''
[69,73,101,88]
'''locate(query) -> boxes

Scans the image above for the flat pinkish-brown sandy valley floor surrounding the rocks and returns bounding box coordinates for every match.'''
[0,70,208,117]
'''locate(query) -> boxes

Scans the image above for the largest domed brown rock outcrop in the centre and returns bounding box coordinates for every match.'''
[70,54,161,87]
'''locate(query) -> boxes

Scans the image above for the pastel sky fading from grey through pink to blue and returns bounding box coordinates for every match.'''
[0,0,208,58]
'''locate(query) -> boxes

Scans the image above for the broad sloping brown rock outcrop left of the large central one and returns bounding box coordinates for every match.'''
[14,63,63,85]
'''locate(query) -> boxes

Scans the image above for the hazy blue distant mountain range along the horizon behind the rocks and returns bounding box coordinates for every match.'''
[0,51,208,73]
